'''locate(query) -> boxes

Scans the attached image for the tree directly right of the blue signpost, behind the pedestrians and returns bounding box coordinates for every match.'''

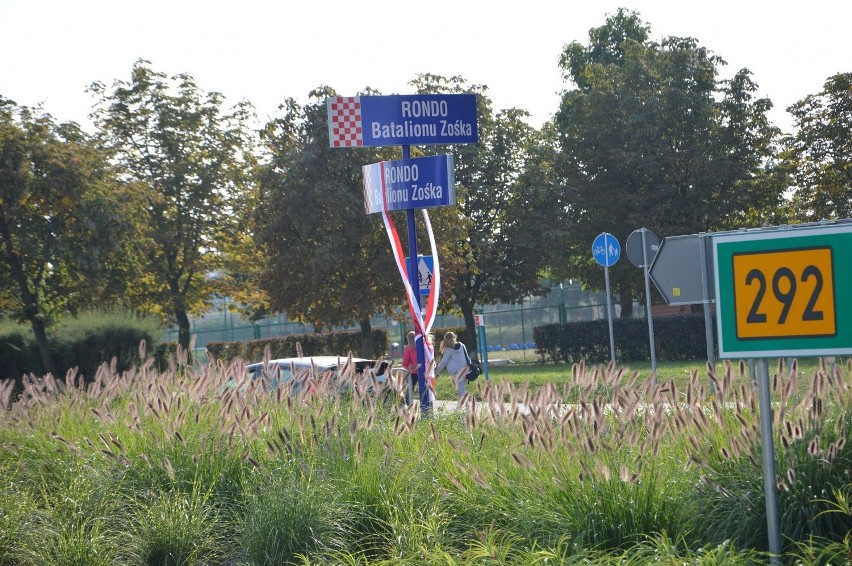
[413,74,557,350]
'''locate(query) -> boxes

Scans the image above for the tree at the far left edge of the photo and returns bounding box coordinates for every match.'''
[0,97,126,375]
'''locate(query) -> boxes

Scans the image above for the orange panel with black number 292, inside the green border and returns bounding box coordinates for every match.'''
[733,247,837,340]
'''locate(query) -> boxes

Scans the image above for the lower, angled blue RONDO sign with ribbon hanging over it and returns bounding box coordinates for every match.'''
[361,155,456,214]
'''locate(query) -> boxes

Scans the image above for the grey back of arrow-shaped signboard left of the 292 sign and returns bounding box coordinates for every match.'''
[650,234,712,305]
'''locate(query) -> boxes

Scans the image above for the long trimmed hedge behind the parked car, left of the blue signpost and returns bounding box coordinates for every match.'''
[207,329,388,361]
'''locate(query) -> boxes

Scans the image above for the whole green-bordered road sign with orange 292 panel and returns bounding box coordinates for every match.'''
[712,222,852,358]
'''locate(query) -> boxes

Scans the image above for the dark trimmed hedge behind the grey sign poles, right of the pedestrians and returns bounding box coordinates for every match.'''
[533,314,716,362]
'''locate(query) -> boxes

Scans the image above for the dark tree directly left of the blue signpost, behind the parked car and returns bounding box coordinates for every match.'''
[255,87,404,356]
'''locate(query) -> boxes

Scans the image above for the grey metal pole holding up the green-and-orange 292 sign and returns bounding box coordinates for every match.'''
[757,358,781,566]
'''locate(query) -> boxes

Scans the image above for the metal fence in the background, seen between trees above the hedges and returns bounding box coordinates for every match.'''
[166,284,641,362]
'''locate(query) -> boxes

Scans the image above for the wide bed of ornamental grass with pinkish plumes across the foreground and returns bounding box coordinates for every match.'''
[0,344,852,565]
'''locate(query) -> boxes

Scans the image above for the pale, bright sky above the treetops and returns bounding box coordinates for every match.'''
[0,0,852,132]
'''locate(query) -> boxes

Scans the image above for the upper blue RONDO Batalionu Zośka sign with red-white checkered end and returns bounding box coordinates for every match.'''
[326,94,479,147]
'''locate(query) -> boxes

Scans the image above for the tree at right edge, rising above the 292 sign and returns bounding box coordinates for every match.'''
[783,73,852,222]
